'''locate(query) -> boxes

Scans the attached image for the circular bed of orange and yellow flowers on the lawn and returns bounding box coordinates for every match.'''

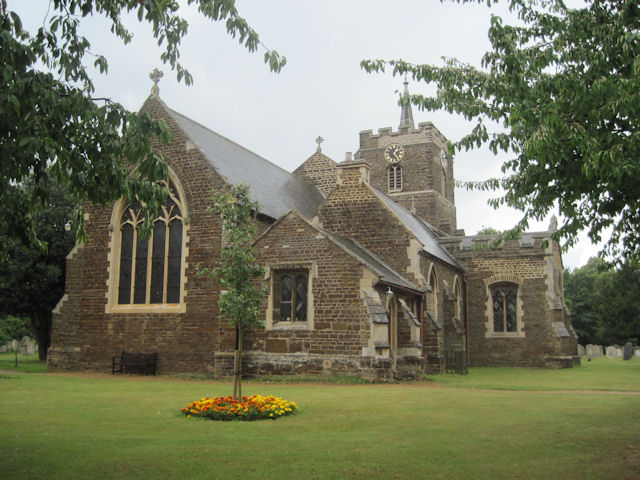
[180,395,298,420]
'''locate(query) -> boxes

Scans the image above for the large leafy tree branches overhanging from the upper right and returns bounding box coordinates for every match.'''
[362,0,640,256]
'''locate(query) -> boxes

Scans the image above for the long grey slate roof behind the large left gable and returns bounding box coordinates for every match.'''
[167,107,324,219]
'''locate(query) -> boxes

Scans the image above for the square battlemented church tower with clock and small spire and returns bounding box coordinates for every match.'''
[355,80,457,236]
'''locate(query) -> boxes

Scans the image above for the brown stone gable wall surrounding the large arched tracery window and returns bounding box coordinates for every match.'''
[48,96,232,374]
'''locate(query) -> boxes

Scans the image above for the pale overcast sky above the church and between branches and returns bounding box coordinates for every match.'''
[8,0,597,268]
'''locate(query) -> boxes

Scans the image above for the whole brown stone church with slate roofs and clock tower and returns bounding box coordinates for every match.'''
[48,79,579,379]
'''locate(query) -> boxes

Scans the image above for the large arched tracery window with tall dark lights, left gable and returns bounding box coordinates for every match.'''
[117,181,184,305]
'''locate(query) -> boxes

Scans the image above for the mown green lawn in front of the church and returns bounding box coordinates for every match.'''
[0,359,640,480]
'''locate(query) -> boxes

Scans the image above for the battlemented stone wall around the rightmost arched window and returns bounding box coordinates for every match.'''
[442,232,579,367]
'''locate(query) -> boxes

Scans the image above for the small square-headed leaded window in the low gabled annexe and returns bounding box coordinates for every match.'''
[274,271,309,322]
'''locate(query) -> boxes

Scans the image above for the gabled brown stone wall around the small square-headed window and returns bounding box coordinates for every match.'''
[244,213,391,378]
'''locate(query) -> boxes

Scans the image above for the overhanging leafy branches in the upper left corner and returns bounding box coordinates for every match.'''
[0,0,285,253]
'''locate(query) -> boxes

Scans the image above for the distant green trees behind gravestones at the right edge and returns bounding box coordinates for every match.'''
[564,258,640,345]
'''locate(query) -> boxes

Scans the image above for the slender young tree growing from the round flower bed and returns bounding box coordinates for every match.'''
[201,184,267,398]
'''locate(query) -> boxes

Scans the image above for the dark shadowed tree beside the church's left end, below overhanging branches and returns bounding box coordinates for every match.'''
[0,170,75,360]
